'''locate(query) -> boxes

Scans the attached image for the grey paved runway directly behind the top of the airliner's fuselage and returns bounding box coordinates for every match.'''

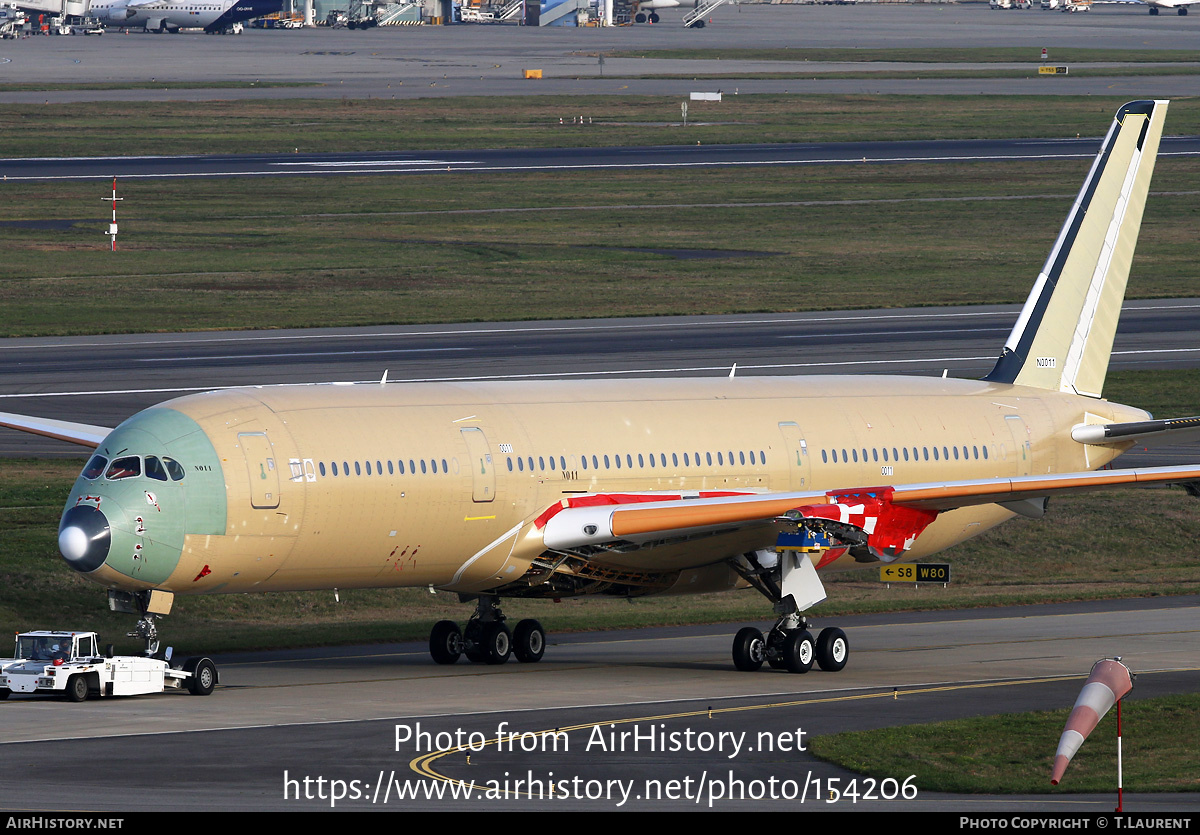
[0,299,1200,455]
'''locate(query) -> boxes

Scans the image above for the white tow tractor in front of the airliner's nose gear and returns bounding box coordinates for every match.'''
[0,631,217,702]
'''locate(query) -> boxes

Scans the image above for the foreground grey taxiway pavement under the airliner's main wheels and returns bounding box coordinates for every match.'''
[0,590,1200,813]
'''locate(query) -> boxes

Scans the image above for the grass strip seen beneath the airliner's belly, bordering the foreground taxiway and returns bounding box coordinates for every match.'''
[0,370,1200,651]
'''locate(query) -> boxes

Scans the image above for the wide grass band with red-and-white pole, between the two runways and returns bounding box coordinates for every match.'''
[0,157,1200,336]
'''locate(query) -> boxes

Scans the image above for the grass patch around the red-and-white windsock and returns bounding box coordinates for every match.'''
[809,691,1200,794]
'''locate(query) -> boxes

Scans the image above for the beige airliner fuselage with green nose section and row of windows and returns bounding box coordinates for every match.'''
[60,377,1146,596]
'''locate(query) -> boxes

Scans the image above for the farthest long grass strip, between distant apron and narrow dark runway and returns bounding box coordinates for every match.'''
[0,95,1200,159]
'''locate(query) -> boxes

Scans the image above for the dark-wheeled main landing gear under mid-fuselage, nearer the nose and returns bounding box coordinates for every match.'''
[430,595,546,663]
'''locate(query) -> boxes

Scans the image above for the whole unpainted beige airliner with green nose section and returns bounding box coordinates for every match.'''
[0,101,1200,673]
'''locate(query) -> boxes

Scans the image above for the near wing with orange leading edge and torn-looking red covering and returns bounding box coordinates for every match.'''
[538,464,1200,559]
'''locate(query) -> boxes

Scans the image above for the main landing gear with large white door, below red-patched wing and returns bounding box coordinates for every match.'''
[733,551,850,673]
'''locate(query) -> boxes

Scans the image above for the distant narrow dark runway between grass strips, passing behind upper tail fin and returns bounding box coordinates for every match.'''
[7,137,1200,182]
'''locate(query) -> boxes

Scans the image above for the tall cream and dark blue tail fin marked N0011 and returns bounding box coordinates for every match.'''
[984,101,1166,397]
